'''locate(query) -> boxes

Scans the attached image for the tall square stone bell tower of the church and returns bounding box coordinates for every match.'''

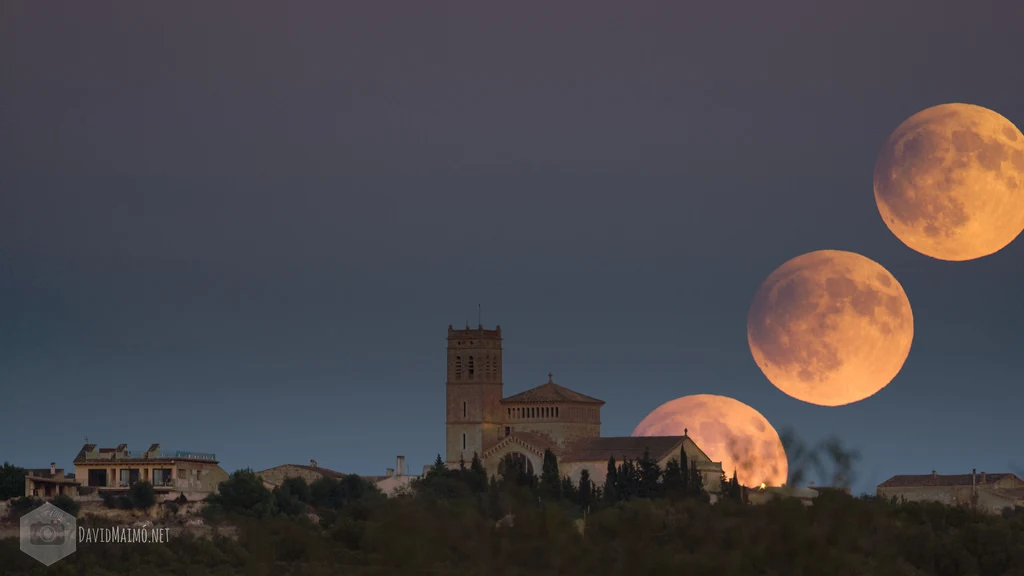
[444,325,504,465]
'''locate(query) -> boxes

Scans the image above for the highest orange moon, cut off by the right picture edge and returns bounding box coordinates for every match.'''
[874,104,1024,261]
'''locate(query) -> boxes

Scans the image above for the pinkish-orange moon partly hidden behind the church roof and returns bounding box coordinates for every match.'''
[633,394,790,487]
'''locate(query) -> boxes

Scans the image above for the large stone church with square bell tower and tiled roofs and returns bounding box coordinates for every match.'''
[445,325,722,493]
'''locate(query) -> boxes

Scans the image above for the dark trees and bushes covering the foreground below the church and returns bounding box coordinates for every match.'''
[0,446,1024,576]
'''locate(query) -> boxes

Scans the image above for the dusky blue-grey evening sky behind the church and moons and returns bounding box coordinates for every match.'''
[0,0,1024,491]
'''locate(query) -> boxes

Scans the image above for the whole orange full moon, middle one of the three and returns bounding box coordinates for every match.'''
[746,250,913,406]
